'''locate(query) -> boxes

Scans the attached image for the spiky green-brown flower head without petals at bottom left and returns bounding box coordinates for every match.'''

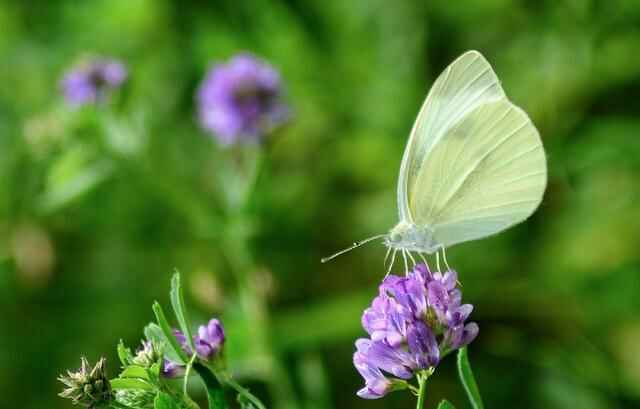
[58,358,113,408]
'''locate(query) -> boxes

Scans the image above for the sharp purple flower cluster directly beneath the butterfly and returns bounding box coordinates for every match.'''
[353,264,478,399]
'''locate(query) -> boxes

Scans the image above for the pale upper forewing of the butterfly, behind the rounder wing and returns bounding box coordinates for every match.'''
[398,51,505,222]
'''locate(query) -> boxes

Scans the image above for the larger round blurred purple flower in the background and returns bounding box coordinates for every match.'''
[196,54,288,145]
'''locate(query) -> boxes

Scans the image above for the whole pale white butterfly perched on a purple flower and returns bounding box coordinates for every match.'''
[322,51,547,269]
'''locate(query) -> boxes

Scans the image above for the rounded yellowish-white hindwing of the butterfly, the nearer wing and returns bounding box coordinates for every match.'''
[410,98,547,247]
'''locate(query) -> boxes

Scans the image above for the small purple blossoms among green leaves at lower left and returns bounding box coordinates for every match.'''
[162,318,225,378]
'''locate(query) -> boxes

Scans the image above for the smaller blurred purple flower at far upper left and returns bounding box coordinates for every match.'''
[61,59,127,106]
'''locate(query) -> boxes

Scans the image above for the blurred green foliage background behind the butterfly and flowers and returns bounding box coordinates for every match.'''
[0,0,640,409]
